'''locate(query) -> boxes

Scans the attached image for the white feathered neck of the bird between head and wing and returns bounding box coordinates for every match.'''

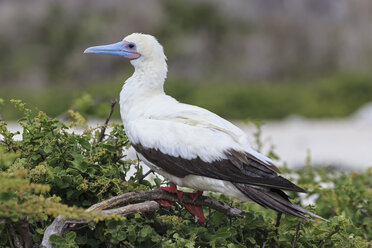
[120,59,167,123]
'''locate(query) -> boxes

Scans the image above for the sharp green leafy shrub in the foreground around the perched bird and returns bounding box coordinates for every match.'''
[0,101,372,247]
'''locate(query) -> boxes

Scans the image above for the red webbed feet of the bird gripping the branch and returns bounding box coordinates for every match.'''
[157,182,205,223]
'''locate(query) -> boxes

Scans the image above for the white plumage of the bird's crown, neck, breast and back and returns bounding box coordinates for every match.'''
[120,34,270,165]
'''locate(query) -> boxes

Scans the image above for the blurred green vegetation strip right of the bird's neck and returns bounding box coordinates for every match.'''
[165,73,372,119]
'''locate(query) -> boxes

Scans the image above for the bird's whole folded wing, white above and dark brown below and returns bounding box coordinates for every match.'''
[129,100,304,192]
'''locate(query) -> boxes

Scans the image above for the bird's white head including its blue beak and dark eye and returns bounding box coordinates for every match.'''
[84,33,167,73]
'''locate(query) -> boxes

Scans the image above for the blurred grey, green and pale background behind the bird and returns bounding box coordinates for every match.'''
[0,0,372,169]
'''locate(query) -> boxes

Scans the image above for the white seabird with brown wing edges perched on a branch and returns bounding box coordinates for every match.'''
[84,33,323,219]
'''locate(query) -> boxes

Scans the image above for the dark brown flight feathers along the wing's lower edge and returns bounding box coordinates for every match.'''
[132,144,305,192]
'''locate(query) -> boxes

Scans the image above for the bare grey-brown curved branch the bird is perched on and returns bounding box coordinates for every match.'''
[41,189,245,248]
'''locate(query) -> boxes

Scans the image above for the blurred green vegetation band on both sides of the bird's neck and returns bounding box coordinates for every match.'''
[1,71,372,120]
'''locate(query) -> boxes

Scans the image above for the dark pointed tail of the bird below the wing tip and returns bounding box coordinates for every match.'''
[234,183,326,220]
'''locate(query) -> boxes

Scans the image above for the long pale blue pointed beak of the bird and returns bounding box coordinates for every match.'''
[84,41,140,59]
